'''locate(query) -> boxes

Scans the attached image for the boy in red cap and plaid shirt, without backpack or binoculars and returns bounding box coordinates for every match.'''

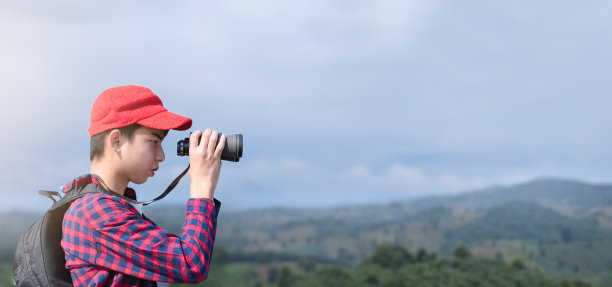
[62,86,225,286]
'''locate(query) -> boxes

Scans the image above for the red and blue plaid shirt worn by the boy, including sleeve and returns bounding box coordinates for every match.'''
[62,175,220,286]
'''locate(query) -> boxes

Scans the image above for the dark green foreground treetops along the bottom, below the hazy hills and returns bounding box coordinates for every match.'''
[176,243,600,287]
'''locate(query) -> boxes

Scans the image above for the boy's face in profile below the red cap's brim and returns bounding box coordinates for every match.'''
[121,127,166,184]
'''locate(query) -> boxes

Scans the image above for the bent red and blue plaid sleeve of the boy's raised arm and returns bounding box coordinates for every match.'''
[86,195,220,283]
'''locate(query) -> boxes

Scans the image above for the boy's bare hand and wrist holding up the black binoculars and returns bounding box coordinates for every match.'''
[189,129,225,199]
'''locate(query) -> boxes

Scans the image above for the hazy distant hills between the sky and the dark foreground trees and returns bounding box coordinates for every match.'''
[0,179,612,286]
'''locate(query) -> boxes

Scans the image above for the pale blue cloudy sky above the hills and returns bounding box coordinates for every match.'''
[0,0,612,210]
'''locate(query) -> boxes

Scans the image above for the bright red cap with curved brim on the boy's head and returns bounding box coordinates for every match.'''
[89,86,191,136]
